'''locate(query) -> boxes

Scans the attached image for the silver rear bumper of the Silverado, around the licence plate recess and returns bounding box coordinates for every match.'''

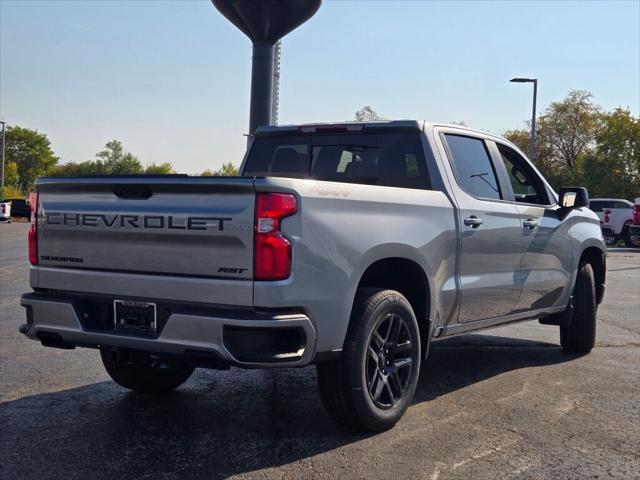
[20,293,316,368]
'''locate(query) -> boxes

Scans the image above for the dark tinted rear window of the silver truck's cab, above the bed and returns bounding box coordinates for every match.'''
[243,133,429,189]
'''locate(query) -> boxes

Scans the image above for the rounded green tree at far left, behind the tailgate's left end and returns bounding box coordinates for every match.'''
[5,125,58,191]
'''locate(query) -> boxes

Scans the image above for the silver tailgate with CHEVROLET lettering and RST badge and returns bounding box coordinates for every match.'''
[37,176,255,284]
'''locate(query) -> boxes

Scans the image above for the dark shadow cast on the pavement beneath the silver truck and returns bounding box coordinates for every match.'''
[0,335,576,479]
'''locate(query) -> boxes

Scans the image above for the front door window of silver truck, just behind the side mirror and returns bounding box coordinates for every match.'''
[498,144,551,205]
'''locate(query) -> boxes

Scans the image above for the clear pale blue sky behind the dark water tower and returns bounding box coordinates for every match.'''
[0,0,640,173]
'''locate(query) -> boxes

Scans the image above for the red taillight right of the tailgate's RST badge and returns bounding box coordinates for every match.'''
[253,193,298,280]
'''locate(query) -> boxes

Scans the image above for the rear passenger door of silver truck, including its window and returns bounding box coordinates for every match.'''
[440,129,522,322]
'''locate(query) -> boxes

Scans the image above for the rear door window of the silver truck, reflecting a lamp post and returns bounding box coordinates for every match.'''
[445,134,502,200]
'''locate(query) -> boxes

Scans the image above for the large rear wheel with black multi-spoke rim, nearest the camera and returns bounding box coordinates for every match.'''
[317,289,421,432]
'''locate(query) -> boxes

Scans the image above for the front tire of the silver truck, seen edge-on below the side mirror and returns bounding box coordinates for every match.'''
[560,263,598,353]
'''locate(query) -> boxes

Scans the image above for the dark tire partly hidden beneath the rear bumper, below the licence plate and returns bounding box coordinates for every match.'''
[100,348,194,393]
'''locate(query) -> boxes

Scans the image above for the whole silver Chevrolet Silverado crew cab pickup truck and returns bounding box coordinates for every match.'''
[20,121,606,431]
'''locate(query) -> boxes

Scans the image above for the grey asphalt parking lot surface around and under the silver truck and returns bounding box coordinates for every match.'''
[0,223,640,480]
